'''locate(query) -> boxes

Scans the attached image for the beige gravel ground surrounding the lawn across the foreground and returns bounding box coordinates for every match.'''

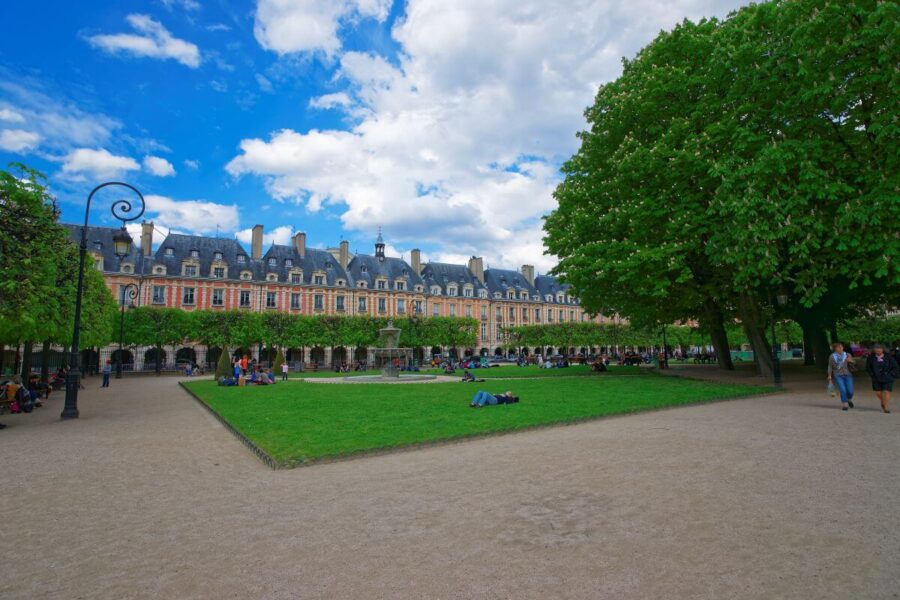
[0,371,900,599]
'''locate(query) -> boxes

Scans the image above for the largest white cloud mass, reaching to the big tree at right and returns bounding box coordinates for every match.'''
[236,0,742,271]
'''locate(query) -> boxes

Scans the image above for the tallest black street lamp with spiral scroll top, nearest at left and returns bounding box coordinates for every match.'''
[60,181,147,419]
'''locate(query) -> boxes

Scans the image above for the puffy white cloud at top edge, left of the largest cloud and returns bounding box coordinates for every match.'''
[253,0,391,56]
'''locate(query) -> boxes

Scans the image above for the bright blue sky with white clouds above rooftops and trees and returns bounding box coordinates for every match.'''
[0,0,740,271]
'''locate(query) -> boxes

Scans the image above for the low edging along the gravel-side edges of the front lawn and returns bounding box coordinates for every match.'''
[178,380,783,470]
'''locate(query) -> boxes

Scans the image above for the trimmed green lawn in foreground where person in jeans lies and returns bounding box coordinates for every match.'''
[186,369,768,465]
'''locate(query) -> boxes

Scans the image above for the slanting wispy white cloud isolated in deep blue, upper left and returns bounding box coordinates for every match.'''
[88,14,200,68]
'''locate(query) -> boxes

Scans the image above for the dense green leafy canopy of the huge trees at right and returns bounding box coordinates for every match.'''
[545,0,900,368]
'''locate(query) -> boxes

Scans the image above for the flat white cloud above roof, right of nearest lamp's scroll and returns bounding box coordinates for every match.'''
[144,195,240,234]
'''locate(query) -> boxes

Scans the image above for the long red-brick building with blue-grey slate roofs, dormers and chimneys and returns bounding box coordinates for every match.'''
[66,222,620,369]
